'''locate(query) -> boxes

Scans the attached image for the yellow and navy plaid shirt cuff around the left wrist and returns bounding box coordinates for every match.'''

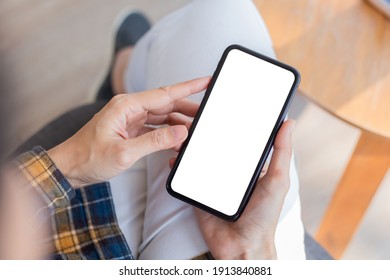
[15,146,75,213]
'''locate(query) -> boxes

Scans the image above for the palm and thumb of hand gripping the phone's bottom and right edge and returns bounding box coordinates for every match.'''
[195,120,294,260]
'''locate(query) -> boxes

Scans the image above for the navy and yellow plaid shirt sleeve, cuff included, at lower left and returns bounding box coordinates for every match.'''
[16,147,134,260]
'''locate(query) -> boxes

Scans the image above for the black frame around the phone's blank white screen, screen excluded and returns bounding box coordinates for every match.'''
[166,45,300,221]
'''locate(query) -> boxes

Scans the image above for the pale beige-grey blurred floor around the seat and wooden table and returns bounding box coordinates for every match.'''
[0,0,390,259]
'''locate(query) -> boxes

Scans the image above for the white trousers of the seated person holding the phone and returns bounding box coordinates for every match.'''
[111,0,305,259]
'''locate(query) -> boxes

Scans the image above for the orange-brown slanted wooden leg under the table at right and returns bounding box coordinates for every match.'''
[316,131,390,259]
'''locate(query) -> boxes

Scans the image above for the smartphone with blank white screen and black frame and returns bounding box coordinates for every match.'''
[167,45,300,221]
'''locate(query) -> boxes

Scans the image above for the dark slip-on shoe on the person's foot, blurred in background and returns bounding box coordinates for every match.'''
[96,12,150,102]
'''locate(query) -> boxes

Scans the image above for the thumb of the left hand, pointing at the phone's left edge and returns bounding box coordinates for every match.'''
[128,125,188,162]
